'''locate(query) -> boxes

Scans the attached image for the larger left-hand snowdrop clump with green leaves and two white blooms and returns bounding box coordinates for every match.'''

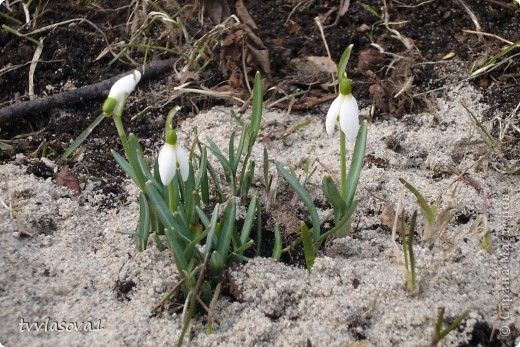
[97,70,263,344]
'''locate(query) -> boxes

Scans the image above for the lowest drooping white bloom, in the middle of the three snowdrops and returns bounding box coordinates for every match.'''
[157,143,190,186]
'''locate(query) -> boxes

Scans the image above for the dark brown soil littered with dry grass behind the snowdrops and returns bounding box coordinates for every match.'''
[0,0,520,179]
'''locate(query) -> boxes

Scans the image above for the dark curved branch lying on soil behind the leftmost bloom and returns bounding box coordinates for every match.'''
[0,58,174,124]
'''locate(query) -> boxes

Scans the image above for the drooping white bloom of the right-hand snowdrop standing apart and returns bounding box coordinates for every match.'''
[325,93,359,142]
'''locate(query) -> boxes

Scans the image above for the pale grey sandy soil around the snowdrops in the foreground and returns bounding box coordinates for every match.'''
[0,74,520,347]
